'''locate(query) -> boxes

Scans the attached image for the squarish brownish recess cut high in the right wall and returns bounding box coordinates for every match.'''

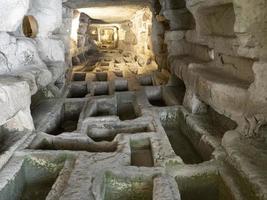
[198,3,235,37]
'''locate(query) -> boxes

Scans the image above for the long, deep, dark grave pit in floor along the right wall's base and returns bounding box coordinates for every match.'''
[160,109,214,164]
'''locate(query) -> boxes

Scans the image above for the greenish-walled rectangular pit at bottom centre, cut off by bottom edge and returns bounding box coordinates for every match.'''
[103,172,153,200]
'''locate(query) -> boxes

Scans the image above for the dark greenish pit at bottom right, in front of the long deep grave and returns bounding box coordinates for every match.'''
[175,173,234,200]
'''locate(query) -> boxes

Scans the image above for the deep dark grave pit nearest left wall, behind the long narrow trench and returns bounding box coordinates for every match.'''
[46,101,84,135]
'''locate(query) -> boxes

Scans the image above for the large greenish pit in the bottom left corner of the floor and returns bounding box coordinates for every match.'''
[0,157,65,200]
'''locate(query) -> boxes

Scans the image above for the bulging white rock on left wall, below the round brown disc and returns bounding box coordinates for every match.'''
[0,32,52,93]
